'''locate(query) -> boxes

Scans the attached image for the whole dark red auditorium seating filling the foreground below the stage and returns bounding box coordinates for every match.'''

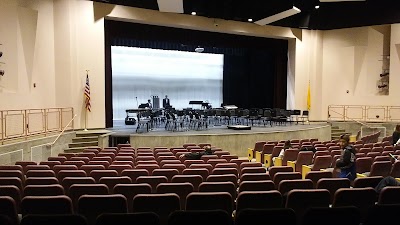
[0,140,400,225]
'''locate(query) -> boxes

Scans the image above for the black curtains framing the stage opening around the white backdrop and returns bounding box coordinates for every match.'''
[105,20,288,127]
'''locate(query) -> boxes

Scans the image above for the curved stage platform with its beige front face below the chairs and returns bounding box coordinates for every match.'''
[108,123,331,157]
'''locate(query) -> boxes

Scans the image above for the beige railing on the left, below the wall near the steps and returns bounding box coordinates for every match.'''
[0,107,74,144]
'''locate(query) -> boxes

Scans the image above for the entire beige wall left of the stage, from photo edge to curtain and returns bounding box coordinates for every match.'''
[0,0,105,128]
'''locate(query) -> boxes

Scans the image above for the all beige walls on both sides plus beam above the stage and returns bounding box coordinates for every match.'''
[0,0,400,128]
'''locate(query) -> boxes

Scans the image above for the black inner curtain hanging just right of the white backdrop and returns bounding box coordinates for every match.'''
[223,50,280,109]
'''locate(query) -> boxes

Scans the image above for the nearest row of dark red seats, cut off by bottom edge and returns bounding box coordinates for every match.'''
[8,204,400,225]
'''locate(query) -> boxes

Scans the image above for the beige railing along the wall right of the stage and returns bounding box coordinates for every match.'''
[328,105,400,122]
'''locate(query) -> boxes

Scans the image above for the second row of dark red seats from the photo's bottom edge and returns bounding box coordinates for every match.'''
[0,187,400,224]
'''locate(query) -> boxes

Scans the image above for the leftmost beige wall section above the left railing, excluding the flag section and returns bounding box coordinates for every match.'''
[0,0,55,109]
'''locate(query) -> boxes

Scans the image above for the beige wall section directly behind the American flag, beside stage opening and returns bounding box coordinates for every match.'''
[54,0,105,128]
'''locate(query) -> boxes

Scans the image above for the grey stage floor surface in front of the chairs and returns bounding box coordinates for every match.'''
[107,120,327,136]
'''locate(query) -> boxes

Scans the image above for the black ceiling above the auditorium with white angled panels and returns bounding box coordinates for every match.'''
[92,0,400,30]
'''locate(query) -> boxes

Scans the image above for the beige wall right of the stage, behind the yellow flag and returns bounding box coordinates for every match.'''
[295,25,394,120]
